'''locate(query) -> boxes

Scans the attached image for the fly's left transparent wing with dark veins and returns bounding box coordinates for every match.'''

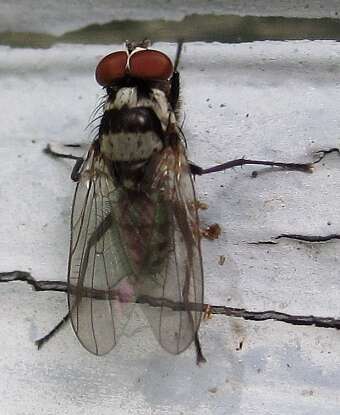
[68,148,135,355]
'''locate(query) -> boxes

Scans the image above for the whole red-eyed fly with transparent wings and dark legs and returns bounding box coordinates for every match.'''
[39,42,311,362]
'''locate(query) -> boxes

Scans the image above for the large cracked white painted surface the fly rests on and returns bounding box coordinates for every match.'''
[0,41,340,415]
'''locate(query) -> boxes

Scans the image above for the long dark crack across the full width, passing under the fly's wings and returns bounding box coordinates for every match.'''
[0,271,340,330]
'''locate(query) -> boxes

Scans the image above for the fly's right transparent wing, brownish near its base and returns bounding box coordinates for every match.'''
[137,144,203,354]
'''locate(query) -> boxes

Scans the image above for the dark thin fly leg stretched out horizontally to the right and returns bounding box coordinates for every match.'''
[189,158,313,176]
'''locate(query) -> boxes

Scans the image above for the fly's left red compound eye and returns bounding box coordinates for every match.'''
[96,51,128,86]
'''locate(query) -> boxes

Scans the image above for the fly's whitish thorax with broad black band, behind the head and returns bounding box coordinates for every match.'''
[99,86,176,161]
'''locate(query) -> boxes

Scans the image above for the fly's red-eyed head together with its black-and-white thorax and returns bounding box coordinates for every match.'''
[96,42,179,162]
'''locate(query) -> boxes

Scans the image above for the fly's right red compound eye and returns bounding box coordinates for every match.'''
[129,49,173,80]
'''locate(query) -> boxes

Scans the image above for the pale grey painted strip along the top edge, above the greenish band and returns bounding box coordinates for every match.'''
[0,0,340,35]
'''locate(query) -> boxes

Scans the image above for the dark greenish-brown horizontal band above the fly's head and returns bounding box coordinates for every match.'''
[0,14,340,48]
